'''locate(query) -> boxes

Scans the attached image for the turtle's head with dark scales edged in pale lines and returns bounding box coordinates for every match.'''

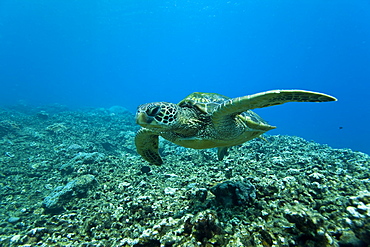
[136,102,179,130]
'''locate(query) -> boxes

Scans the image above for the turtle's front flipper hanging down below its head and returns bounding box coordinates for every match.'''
[135,128,163,165]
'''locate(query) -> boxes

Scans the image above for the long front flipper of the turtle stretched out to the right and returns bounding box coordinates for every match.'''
[212,90,337,123]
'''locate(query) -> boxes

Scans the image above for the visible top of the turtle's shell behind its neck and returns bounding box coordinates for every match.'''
[178,92,230,114]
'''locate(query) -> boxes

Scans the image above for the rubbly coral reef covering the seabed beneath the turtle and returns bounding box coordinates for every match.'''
[0,105,370,247]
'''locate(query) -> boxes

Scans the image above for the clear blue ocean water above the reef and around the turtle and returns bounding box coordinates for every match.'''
[0,0,370,153]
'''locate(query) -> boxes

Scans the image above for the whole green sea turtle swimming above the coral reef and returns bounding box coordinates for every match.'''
[135,90,337,165]
